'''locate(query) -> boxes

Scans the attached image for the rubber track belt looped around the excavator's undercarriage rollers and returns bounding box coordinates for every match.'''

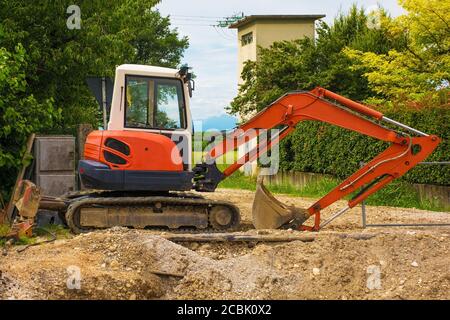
[65,196,240,234]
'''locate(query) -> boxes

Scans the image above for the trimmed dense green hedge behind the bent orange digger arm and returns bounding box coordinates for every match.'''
[280,106,450,185]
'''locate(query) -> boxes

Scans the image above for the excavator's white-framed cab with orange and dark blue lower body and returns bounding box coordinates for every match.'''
[79,65,193,191]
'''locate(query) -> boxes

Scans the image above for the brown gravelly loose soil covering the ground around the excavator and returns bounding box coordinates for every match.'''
[0,189,450,299]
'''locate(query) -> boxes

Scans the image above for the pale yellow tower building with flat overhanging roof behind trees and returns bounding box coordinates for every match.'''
[229,14,325,84]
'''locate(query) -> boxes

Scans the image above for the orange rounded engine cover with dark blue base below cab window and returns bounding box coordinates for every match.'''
[78,130,194,191]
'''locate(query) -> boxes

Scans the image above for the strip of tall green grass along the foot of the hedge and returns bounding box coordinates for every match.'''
[219,166,448,211]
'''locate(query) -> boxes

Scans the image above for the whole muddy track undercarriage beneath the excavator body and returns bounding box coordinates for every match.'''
[48,191,240,233]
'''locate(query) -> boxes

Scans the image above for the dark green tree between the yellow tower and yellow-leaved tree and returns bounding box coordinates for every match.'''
[229,6,404,115]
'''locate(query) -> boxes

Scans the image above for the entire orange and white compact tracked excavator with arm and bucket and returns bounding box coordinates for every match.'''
[21,65,440,233]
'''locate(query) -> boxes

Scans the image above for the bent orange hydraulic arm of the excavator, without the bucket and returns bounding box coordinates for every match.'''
[193,87,440,230]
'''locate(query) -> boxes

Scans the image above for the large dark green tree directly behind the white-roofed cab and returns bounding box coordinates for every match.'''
[0,0,188,132]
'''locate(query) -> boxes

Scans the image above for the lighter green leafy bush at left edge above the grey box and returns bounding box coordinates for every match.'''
[0,45,60,199]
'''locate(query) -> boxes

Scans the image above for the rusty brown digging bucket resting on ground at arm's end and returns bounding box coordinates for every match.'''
[252,178,309,229]
